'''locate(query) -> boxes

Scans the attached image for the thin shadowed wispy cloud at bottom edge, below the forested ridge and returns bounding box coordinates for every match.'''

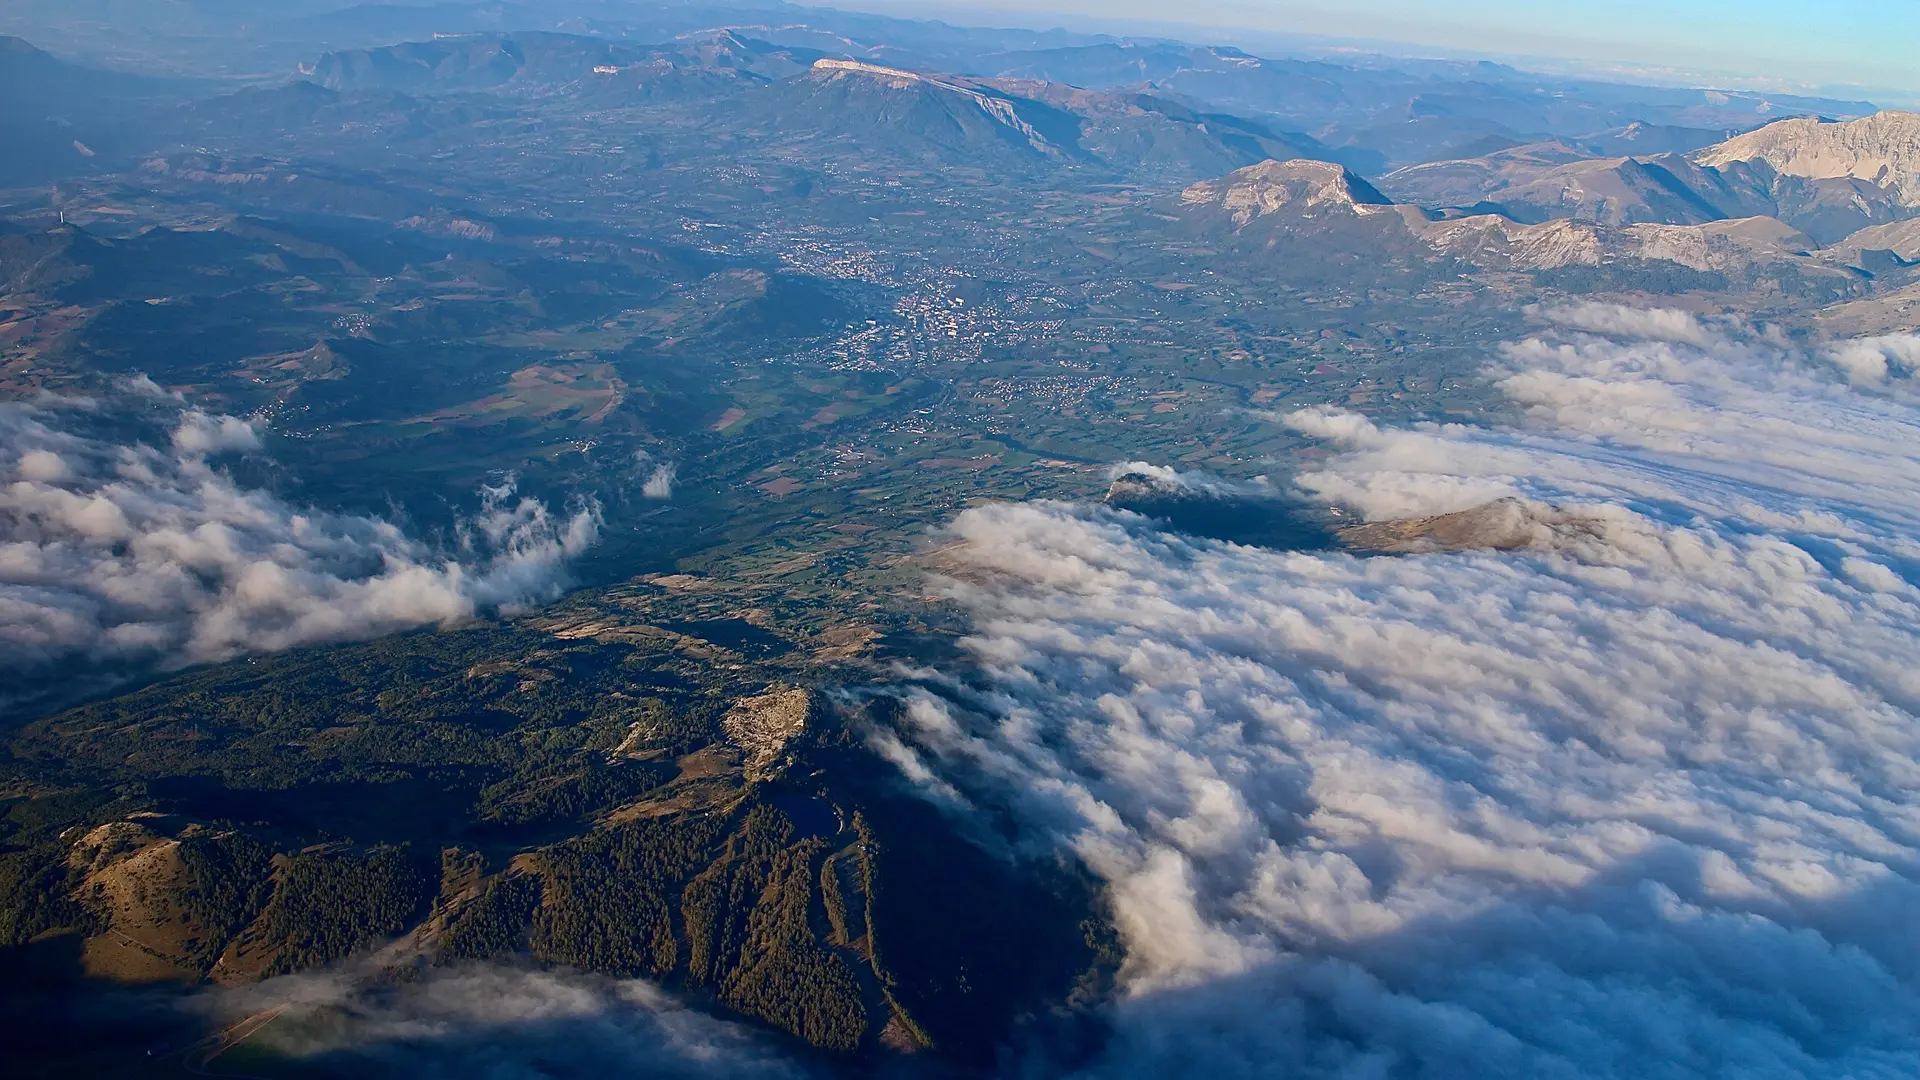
[187,967,810,1080]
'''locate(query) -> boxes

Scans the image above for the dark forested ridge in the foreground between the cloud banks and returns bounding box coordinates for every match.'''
[0,626,1112,1061]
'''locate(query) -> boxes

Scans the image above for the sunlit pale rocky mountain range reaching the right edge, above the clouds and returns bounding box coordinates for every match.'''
[1179,113,1920,288]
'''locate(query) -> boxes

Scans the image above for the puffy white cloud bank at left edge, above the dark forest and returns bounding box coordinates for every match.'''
[0,400,599,699]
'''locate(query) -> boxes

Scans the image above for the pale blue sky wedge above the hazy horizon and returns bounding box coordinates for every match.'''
[821,0,1920,96]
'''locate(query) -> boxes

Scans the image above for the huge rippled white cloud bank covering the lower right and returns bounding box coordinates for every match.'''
[887,309,1920,1080]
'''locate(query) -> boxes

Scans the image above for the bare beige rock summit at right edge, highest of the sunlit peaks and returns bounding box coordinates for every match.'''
[1693,111,1920,206]
